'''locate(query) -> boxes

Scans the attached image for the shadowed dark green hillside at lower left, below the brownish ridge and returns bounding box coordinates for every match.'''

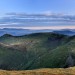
[0,45,28,70]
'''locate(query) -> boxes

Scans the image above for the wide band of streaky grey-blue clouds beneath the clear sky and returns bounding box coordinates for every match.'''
[0,13,75,29]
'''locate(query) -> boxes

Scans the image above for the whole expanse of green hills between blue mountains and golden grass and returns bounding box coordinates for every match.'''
[0,32,75,70]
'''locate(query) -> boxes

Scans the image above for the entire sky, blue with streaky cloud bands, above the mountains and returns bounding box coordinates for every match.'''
[0,0,75,29]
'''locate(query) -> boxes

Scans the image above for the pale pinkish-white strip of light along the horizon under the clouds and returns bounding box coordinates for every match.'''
[0,26,75,30]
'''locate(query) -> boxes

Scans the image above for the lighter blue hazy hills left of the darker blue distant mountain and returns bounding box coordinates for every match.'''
[0,28,52,36]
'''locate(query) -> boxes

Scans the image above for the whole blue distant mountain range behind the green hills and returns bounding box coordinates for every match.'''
[0,28,75,36]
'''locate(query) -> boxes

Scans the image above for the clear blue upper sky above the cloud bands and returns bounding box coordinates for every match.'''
[0,0,75,14]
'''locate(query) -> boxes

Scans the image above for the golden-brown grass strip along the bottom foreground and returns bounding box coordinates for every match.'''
[0,67,75,75]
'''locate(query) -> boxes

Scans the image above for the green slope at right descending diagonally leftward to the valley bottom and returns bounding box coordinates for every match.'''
[30,36,75,69]
